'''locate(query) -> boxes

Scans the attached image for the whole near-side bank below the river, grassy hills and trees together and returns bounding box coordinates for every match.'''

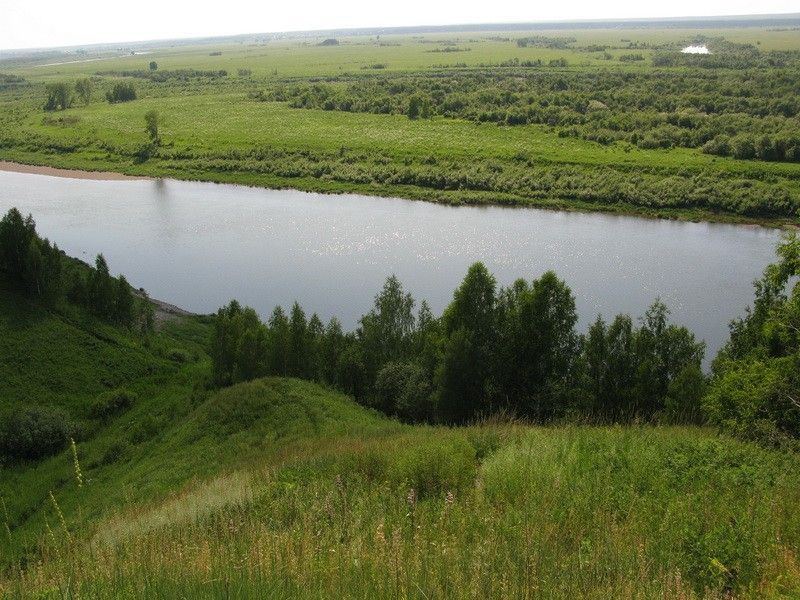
[0,205,800,598]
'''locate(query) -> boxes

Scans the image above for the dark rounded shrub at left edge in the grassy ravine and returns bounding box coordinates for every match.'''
[0,406,72,460]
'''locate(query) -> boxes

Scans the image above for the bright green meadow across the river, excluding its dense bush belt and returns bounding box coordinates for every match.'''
[0,22,800,224]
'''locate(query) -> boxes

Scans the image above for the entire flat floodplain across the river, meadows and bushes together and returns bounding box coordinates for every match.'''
[0,22,800,224]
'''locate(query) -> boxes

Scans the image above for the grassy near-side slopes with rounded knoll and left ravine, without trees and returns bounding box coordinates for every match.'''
[0,290,800,598]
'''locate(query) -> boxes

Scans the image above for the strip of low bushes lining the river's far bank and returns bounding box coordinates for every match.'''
[0,131,800,218]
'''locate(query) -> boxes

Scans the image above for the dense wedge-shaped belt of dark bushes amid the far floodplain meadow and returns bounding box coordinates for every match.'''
[260,66,800,161]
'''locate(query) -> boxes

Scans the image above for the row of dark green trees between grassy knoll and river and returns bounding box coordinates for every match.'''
[212,263,705,423]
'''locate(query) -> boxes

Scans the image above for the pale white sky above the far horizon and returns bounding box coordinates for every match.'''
[0,0,799,49]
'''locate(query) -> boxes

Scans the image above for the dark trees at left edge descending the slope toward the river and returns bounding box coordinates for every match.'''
[0,208,153,332]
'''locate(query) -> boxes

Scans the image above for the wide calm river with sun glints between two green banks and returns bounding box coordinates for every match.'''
[0,172,780,364]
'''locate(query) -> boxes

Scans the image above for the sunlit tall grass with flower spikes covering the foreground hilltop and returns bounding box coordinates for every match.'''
[6,425,800,598]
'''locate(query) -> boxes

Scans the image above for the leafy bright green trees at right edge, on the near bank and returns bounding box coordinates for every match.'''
[703,234,800,449]
